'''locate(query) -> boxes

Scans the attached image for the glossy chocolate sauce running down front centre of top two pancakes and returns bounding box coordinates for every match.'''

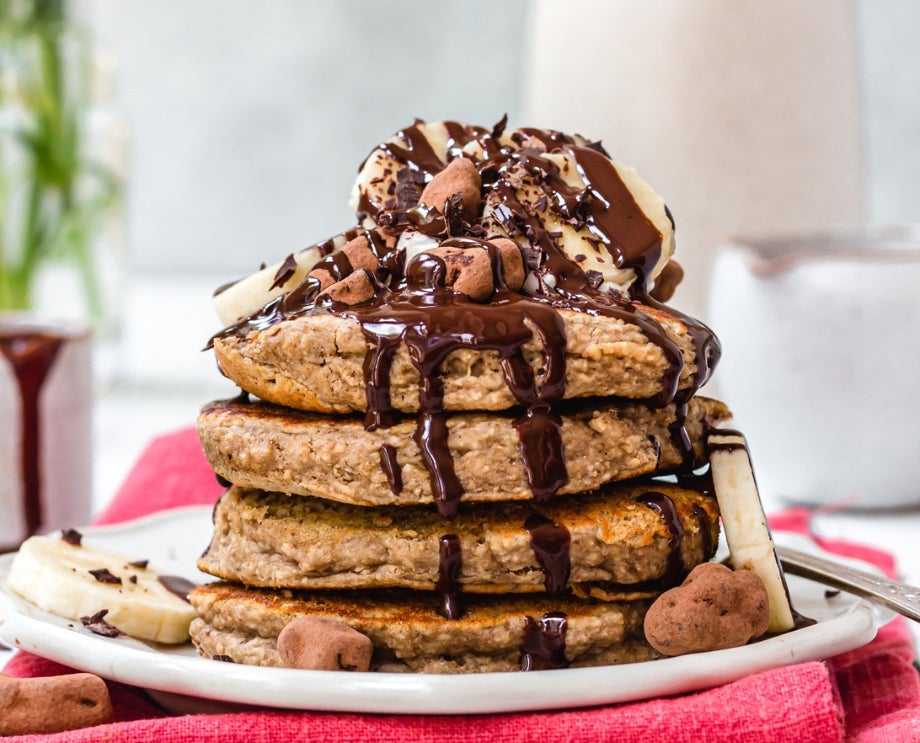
[352,290,568,518]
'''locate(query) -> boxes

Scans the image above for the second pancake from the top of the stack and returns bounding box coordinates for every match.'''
[198,397,730,506]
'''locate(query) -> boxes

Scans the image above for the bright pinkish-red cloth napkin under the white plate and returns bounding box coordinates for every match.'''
[4,429,920,743]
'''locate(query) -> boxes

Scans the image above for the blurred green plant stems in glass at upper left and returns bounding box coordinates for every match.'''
[0,0,122,319]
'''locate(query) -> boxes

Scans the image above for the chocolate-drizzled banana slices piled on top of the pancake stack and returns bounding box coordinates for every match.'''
[214,121,674,327]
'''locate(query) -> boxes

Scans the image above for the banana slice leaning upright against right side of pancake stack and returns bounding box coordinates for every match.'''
[708,429,795,632]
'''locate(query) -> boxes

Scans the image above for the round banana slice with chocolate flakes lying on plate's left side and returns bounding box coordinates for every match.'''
[8,536,196,644]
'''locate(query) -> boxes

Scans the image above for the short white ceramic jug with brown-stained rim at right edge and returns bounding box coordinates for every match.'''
[708,226,920,508]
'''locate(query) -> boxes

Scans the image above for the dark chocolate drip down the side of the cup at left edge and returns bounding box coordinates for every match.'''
[0,332,62,536]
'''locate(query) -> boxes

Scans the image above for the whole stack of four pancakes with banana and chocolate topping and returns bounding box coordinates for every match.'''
[192,122,729,672]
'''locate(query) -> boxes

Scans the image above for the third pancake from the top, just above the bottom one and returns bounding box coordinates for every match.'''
[198,481,719,598]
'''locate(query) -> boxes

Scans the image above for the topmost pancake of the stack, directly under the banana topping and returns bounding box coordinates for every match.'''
[214,300,709,413]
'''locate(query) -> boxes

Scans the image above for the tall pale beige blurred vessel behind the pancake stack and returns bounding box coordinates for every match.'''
[524,0,863,316]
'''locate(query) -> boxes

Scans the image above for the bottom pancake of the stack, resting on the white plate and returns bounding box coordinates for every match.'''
[190,583,657,673]
